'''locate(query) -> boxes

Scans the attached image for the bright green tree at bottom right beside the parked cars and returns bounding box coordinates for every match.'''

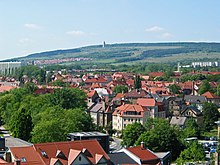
[176,142,206,165]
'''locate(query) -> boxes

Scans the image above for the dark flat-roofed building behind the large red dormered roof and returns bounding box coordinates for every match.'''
[67,132,109,153]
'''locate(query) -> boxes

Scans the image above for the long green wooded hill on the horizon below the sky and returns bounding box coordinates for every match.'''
[4,42,220,64]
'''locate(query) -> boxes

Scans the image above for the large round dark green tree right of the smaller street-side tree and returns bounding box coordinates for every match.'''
[138,119,182,159]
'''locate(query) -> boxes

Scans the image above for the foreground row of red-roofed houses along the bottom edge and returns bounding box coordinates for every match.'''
[0,140,171,165]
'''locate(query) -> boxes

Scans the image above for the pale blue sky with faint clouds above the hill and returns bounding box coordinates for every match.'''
[0,0,220,60]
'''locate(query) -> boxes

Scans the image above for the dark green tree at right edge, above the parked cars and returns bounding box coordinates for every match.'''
[203,102,219,131]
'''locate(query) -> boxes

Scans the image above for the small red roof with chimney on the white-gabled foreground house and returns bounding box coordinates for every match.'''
[126,146,160,163]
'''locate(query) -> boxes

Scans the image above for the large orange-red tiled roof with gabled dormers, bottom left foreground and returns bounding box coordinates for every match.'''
[10,140,110,165]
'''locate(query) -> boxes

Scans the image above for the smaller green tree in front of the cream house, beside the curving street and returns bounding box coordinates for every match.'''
[122,122,145,146]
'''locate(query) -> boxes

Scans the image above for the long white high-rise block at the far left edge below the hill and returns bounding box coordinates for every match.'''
[0,62,22,75]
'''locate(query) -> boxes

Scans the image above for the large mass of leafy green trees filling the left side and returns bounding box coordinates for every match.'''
[0,84,95,143]
